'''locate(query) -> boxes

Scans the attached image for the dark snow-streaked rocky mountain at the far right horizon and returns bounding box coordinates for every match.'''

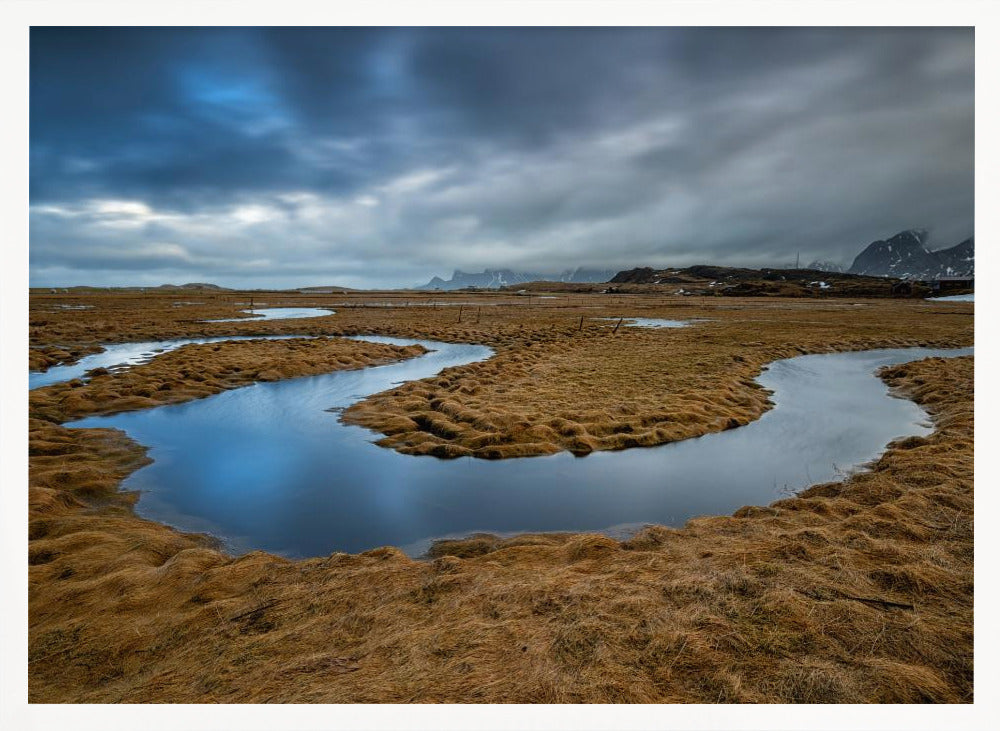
[847,229,976,279]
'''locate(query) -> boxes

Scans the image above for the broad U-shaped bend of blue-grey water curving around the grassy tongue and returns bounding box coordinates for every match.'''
[70,337,972,557]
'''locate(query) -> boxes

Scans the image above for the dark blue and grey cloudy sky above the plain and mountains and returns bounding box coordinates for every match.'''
[29,27,974,288]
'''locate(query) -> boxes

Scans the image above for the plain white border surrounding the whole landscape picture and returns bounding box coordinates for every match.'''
[0,0,1000,731]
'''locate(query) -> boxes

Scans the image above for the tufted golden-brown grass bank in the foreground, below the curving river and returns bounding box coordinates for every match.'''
[29,358,973,702]
